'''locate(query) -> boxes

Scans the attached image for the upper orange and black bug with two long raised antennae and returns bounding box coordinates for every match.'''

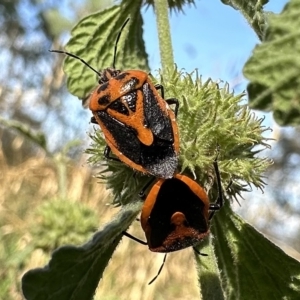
[51,19,179,178]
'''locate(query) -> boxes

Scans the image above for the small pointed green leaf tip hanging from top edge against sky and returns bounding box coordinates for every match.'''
[221,0,269,40]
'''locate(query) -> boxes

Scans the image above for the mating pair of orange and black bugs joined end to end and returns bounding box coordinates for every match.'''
[51,19,223,282]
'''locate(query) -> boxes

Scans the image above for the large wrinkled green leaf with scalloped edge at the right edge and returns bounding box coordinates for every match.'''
[244,0,300,125]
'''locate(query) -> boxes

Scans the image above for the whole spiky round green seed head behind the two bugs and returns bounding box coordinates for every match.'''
[87,70,271,204]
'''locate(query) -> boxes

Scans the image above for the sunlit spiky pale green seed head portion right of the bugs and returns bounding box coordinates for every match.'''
[160,70,270,188]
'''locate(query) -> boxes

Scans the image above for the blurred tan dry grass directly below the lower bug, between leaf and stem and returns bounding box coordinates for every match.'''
[95,222,199,300]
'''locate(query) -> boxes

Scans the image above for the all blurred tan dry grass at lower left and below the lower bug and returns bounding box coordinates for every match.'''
[0,154,199,300]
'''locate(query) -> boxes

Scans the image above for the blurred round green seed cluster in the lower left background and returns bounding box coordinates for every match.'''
[30,199,98,252]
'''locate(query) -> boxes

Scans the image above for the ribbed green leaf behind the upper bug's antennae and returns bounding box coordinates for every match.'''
[56,1,149,99]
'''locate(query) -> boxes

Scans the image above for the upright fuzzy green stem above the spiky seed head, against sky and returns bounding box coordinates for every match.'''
[154,0,174,74]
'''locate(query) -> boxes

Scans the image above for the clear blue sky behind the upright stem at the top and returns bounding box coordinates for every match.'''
[143,0,288,89]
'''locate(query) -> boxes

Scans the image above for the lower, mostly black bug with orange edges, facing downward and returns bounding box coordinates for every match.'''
[123,159,224,284]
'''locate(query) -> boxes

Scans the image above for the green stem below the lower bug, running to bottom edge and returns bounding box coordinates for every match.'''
[195,236,225,300]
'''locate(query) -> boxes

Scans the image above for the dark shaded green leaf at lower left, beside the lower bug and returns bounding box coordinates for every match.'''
[22,202,141,300]
